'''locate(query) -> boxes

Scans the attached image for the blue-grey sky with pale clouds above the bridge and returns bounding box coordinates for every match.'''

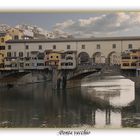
[0,12,140,37]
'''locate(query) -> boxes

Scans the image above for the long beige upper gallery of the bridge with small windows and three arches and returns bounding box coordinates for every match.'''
[2,37,140,70]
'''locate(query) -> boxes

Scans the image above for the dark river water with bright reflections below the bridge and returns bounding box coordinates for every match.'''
[0,76,140,128]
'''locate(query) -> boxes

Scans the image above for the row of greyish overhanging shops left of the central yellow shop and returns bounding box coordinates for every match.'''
[5,51,45,71]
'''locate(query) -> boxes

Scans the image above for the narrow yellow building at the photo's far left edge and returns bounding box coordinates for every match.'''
[0,33,12,70]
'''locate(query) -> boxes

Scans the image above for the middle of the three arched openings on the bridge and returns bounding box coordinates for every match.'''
[92,52,105,64]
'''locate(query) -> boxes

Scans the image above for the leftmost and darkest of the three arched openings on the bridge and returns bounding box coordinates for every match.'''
[78,52,90,64]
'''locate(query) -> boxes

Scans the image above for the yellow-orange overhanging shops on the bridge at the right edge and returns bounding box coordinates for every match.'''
[121,49,140,69]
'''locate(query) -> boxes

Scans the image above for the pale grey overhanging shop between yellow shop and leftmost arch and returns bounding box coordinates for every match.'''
[59,51,77,69]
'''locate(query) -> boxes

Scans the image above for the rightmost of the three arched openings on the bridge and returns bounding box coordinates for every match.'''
[107,51,119,65]
